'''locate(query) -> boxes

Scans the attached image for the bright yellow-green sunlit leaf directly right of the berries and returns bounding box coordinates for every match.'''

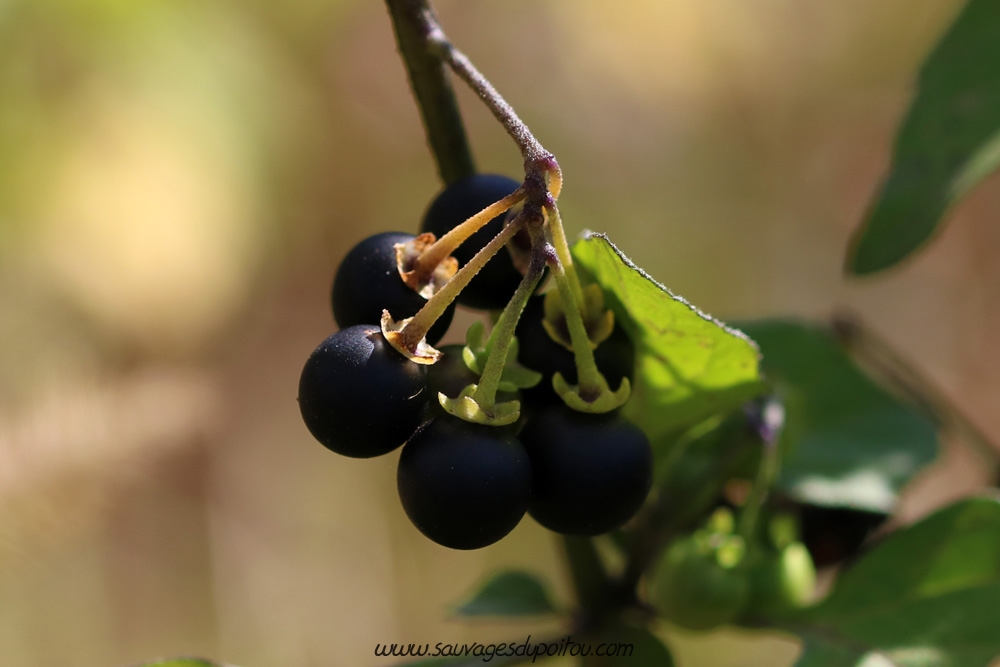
[572,233,764,442]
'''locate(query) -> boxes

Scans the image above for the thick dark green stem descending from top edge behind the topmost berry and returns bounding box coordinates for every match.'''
[386,0,476,184]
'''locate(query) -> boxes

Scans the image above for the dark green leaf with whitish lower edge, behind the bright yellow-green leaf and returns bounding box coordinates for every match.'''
[741,320,937,512]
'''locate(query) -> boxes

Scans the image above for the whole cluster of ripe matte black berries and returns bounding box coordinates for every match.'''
[299,175,653,549]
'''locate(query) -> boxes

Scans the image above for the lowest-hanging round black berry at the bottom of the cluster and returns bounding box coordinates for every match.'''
[396,416,531,549]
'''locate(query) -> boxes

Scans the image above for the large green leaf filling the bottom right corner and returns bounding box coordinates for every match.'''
[794,498,1000,667]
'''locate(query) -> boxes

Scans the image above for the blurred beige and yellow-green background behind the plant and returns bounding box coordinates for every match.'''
[0,0,1000,667]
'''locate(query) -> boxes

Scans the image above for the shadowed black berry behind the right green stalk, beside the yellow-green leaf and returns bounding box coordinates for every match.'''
[515,294,635,408]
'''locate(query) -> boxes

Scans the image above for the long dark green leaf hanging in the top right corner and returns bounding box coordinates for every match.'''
[847,0,1000,275]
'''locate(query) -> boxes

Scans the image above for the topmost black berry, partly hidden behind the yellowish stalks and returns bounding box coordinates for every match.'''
[420,174,527,310]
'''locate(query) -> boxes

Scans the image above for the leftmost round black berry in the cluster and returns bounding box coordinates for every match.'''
[299,324,430,458]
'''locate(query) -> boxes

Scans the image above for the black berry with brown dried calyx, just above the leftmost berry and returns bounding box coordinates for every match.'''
[331,232,455,345]
